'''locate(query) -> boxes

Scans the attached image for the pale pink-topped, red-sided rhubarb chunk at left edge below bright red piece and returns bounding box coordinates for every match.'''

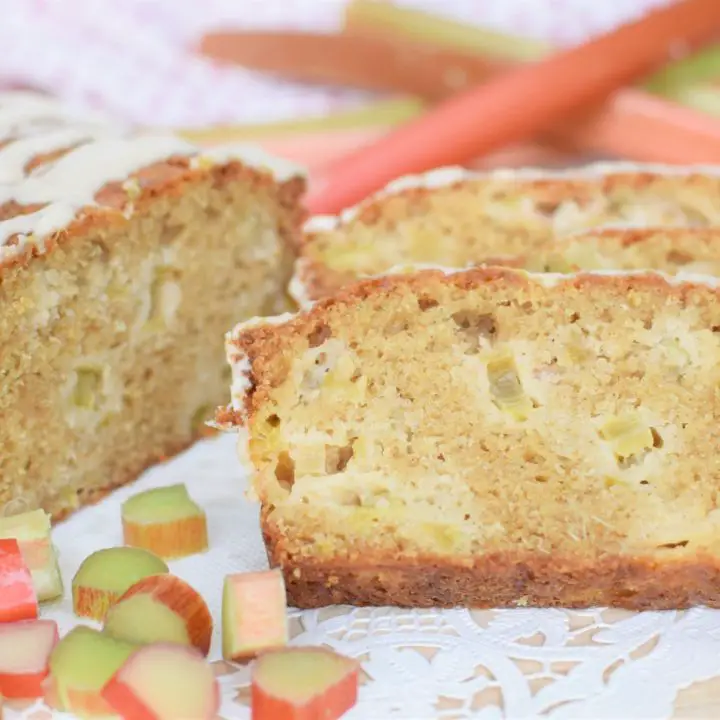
[0,620,58,699]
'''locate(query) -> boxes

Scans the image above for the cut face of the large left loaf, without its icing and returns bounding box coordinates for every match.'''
[0,158,302,519]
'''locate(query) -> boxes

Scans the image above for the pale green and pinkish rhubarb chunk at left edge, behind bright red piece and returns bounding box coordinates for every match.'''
[0,510,63,602]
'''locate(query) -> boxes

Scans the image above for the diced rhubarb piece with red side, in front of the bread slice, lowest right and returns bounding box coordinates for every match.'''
[251,647,360,720]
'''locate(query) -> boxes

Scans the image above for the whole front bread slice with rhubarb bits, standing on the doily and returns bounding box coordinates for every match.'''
[221,267,720,609]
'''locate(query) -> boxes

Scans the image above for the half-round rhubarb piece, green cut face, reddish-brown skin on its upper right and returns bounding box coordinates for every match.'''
[104,575,213,655]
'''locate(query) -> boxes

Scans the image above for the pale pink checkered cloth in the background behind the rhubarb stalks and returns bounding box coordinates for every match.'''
[0,0,669,127]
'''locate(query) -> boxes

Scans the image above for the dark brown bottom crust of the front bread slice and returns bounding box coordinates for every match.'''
[261,508,720,610]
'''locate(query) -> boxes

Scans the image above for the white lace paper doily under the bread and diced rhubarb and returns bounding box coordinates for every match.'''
[7,436,720,720]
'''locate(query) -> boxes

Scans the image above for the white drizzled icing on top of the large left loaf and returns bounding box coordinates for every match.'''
[0,92,302,264]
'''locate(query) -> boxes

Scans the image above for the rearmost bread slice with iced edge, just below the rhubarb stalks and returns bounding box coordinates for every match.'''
[290,163,720,305]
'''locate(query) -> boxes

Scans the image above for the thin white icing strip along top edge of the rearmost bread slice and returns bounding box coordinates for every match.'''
[305,162,720,233]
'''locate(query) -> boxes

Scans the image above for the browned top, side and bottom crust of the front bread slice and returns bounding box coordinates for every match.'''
[224,268,720,610]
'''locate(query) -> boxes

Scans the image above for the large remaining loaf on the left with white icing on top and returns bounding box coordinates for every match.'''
[0,93,304,518]
